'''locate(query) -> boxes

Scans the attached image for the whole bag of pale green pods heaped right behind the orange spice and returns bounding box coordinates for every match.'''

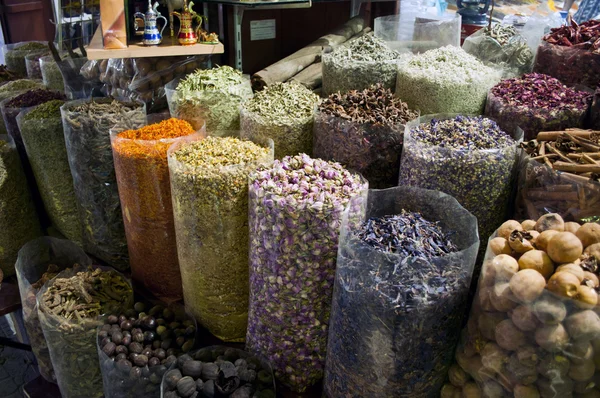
[165,66,252,136]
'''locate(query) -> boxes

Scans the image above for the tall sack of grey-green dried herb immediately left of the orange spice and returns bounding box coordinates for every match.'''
[61,98,146,270]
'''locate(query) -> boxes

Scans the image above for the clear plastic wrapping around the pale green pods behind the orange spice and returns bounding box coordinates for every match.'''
[165,75,253,136]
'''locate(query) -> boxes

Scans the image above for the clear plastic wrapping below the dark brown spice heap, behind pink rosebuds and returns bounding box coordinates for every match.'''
[313,112,405,189]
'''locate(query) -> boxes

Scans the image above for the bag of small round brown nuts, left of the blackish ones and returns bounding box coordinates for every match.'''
[97,302,196,398]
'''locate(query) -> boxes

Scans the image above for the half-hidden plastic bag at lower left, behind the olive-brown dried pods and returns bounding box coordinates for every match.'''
[15,236,92,383]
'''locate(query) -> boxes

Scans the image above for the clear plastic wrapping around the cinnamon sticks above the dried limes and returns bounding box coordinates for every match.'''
[515,152,600,221]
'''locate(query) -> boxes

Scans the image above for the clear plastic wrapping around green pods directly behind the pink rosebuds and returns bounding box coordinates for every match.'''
[240,108,314,159]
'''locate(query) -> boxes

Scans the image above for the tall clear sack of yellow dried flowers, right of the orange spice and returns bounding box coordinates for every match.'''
[169,137,273,342]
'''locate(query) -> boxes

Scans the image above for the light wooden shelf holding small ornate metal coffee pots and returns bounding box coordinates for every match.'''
[86,28,224,59]
